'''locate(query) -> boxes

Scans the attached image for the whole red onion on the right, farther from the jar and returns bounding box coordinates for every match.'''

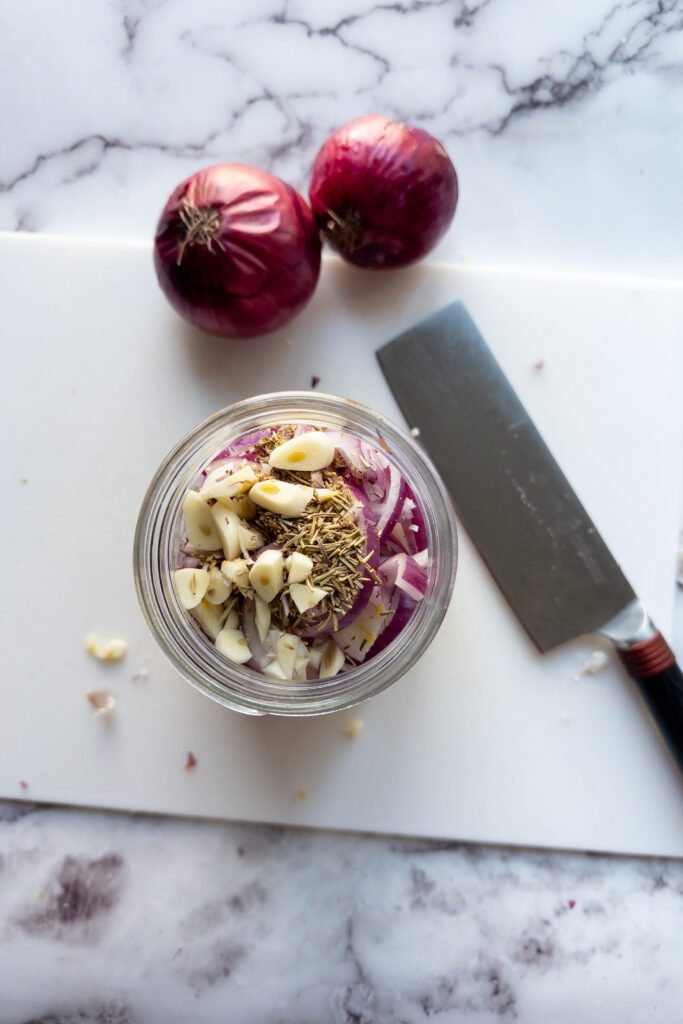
[309,114,458,269]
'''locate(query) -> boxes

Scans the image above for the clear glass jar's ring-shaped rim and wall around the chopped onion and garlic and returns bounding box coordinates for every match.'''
[133,391,458,716]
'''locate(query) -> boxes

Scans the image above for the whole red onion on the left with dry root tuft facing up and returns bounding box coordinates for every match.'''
[155,164,321,338]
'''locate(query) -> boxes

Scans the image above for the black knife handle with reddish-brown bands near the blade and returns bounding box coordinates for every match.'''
[616,633,683,771]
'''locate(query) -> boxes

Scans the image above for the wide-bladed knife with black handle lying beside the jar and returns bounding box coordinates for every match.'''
[377,301,683,771]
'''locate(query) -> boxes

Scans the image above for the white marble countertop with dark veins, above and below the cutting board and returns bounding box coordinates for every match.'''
[0,0,683,1024]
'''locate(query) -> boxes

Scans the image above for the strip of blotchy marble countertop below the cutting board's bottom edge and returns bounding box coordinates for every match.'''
[0,805,683,1024]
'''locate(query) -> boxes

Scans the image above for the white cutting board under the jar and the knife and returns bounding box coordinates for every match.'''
[0,236,683,855]
